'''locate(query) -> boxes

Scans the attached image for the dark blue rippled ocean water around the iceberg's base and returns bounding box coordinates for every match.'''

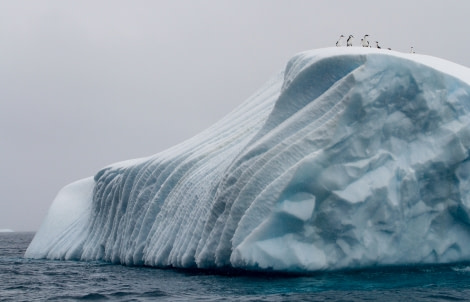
[0,233,470,301]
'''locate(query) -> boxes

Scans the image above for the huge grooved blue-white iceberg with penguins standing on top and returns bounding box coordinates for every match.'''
[25,47,470,272]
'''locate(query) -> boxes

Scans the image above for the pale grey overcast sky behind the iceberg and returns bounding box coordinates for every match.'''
[0,0,470,231]
